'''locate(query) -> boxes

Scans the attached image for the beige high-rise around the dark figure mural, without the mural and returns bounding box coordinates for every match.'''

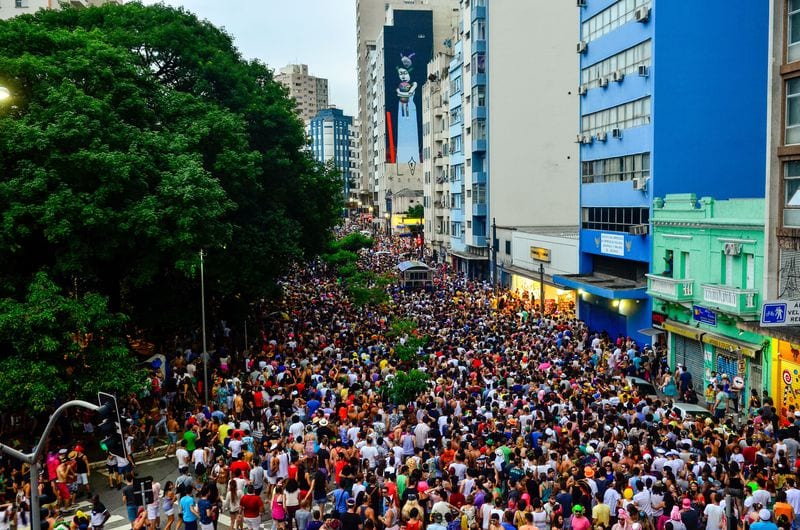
[356,0,458,212]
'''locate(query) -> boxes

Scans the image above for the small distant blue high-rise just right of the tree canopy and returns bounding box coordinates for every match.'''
[309,108,353,202]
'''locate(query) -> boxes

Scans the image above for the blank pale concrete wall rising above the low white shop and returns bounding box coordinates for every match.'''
[486,0,579,226]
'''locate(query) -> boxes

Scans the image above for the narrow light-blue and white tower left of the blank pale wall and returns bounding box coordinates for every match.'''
[449,0,489,278]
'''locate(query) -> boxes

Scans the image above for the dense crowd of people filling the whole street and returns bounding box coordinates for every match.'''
[0,224,800,530]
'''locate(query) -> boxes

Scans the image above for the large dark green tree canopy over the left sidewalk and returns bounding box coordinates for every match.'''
[0,3,341,406]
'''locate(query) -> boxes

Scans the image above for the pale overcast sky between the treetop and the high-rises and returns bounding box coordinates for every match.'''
[144,0,358,116]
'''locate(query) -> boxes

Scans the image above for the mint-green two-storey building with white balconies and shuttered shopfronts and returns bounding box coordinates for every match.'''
[644,193,771,401]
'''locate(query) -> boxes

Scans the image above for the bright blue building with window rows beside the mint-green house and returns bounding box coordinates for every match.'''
[555,0,769,342]
